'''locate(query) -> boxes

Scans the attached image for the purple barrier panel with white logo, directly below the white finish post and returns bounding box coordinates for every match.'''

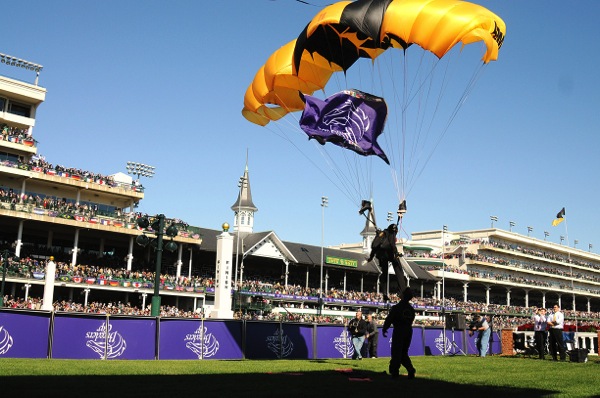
[159,318,243,359]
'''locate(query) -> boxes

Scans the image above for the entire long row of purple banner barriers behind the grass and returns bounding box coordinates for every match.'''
[0,310,501,360]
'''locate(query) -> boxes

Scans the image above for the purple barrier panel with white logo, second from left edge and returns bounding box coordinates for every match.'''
[52,314,156,359]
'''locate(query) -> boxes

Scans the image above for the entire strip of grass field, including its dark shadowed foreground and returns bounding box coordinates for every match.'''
[0,356,600,398]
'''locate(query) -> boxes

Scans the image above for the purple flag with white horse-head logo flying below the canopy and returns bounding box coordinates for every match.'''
[300,90,390,164]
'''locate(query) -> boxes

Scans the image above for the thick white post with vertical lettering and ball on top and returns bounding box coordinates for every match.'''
[210,228,233,319]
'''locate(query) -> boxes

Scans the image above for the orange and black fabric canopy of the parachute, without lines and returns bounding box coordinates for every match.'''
[242,0,506,126]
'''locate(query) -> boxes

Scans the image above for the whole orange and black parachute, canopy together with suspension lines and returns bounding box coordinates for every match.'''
[242,0,506,227]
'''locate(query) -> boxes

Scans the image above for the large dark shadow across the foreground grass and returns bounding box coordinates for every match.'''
[1,366,557,398]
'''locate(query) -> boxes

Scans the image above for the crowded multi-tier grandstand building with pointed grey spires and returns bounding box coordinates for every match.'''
[0,55,600,314]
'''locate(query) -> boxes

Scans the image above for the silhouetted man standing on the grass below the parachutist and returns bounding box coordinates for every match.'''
[381,288,416,379]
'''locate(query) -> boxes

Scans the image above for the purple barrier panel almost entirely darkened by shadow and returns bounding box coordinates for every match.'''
[246,321,314,359]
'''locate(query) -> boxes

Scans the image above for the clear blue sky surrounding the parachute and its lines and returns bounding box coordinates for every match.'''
[0,0,600,252]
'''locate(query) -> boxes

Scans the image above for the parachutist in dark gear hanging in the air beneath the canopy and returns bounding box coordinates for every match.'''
[367,224,407,301]
